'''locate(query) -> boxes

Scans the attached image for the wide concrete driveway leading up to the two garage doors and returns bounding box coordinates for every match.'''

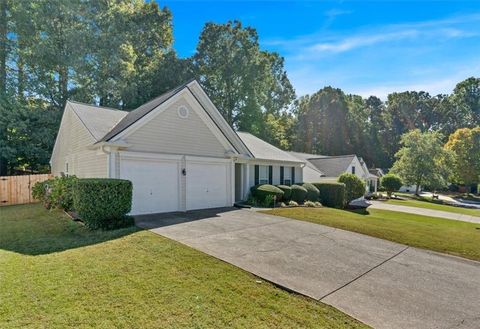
[137,209,480,329]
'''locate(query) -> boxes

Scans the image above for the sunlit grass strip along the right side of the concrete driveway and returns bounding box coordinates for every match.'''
[265,208,480,261]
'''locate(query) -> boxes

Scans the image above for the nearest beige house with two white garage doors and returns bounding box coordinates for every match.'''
[50,81,304,214]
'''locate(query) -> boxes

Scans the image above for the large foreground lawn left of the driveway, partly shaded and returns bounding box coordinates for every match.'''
[0,204,366,328]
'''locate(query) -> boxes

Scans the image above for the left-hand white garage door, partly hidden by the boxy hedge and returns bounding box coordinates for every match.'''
[120,159,180,215]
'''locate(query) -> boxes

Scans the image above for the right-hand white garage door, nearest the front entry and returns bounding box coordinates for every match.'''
[186,160,231,210]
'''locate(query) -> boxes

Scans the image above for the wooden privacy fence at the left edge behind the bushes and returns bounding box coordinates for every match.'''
[0,174,52,206]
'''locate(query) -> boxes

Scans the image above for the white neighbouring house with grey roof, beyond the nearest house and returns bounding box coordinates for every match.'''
[289,152,378,192]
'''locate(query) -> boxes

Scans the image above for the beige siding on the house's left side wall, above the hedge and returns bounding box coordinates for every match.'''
[51,105,107,178]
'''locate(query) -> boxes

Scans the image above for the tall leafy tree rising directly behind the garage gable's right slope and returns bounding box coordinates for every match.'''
[193,21,295,131]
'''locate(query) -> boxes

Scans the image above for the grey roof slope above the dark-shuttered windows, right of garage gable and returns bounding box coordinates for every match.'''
[237,131,304,163]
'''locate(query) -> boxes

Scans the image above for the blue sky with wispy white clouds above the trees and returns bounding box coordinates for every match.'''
[160,0,480,99]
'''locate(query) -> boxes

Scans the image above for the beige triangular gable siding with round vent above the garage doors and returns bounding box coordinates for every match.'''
[125,99,227,158]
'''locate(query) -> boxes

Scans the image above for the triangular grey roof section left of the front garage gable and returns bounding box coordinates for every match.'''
[67,101,128,141]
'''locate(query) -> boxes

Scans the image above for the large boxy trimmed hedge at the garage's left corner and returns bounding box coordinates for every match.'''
[73,178,133,229]
